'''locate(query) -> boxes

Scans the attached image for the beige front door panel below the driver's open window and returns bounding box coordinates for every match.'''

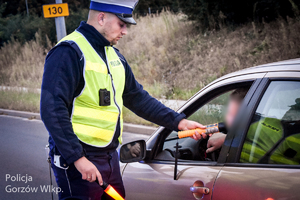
[123,163,222,200]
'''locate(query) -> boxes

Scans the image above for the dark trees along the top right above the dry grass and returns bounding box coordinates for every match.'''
[179,0,300,29]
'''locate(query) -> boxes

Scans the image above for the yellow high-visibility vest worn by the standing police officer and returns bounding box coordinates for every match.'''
[60,31,125,147]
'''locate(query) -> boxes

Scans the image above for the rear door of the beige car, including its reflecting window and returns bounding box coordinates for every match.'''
[212,75,300,200]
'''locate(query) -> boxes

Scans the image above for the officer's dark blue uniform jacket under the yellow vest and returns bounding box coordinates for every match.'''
[40,22,185,164]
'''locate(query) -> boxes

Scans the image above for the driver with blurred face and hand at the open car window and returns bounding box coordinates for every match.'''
[192,88,248,153]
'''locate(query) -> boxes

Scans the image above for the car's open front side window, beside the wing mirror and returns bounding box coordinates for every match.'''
[156,90,236,161]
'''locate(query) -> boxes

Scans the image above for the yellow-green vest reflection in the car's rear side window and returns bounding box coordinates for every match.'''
[240,117,300,165]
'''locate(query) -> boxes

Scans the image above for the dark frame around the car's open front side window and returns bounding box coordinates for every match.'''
[146,78,262,166]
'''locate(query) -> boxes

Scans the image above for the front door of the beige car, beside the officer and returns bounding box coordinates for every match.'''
[123,78,259,200]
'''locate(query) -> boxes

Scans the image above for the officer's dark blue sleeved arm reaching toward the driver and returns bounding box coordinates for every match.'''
[118,53,185,130]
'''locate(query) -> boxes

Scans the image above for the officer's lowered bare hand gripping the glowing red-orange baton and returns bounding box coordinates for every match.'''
[74,157,103,185]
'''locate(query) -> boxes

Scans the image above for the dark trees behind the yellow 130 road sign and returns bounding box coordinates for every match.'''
[0,0,89,46]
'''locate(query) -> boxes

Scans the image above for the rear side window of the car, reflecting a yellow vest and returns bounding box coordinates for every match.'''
[240,81,300,165]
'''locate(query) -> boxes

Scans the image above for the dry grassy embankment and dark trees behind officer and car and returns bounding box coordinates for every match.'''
[0,0,300,125]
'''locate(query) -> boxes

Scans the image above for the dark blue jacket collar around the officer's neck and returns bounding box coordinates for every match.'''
[77,22,111,50]
